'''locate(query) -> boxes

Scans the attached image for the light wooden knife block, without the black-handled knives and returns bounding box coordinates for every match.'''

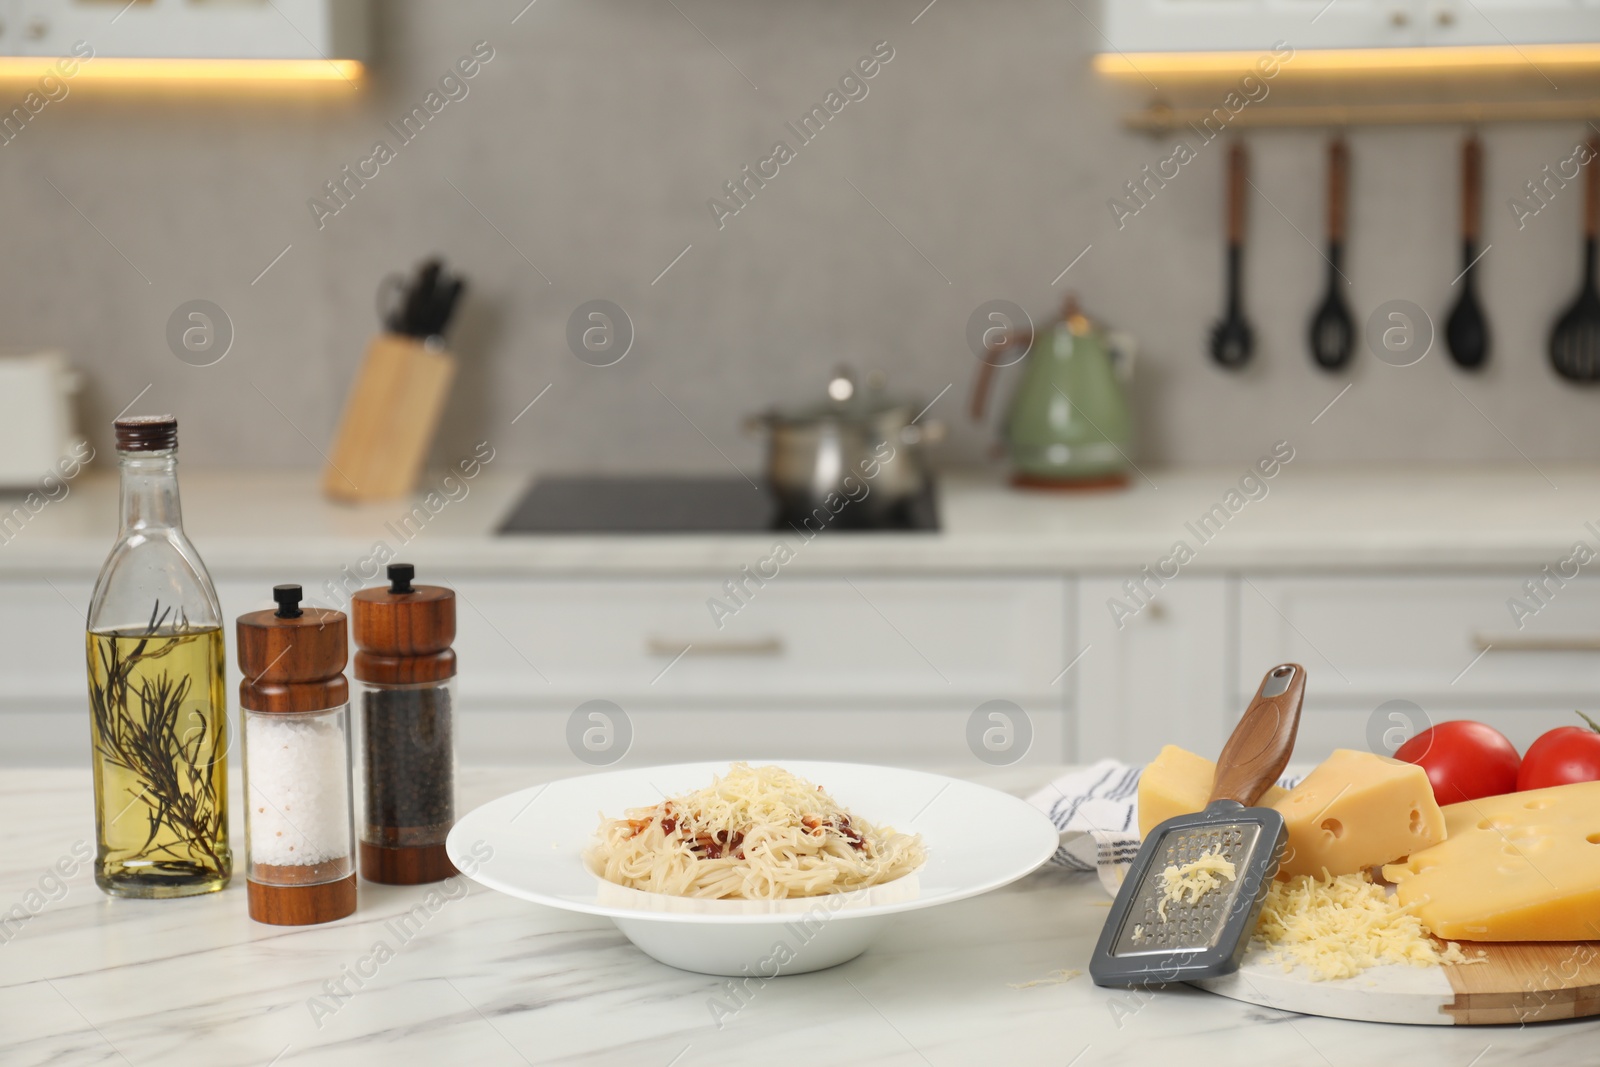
[322,333,456,501]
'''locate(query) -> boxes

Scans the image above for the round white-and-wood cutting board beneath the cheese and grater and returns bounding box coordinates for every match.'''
[1194,941,1600,1025]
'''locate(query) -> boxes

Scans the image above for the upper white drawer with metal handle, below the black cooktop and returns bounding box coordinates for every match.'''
[454,576,1069,710]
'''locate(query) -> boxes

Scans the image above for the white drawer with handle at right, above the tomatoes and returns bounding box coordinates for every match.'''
[1235,574,1600,709]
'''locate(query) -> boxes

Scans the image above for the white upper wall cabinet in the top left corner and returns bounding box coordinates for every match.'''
[0,0,368,59]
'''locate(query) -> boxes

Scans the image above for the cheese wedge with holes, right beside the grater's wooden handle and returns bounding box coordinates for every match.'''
[1272,749,1445,877]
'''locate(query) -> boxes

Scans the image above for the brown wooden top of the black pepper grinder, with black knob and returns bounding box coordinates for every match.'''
[350,563,456,685]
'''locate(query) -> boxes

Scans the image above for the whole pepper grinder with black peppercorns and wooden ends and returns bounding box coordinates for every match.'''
[350,563,456,885]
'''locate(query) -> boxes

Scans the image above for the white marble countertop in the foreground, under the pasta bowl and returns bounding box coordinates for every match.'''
[0,768,1597,1067]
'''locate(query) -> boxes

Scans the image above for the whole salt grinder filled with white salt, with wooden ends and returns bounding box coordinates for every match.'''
[238,585,355,926]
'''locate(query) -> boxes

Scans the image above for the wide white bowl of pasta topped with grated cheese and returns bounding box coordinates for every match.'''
[446,760,1058,976]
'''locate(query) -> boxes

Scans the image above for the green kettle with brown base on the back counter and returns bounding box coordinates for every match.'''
[971,296,1134,490]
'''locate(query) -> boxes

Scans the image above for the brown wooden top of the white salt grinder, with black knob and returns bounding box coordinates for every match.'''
[238,585,350,712]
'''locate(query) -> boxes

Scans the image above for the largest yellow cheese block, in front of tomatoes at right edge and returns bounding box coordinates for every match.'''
[1384,782,1600,941]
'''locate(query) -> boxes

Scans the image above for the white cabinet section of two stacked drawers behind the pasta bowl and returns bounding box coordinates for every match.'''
[454,574,1072,765]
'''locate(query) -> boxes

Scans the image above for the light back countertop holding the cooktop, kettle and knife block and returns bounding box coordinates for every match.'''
[0,464,1600,576]
